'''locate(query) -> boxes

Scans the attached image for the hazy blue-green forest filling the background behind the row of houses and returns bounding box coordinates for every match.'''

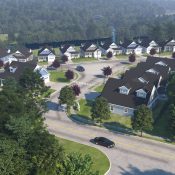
[0,0,175,43]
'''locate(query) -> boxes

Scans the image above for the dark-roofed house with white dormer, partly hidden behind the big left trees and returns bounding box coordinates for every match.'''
[0,60,50,86]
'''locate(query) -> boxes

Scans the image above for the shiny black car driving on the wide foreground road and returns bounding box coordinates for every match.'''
[92,137,115,148]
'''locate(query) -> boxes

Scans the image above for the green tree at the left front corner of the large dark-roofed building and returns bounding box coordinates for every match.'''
[91,97,111,123]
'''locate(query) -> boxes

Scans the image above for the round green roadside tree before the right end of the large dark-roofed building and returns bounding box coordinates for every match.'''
[132,105,153,137]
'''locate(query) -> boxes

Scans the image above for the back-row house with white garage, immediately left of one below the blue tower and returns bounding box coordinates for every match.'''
[80,43,102,59]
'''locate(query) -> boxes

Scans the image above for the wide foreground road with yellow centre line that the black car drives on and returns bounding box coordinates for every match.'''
[45,98,175,175]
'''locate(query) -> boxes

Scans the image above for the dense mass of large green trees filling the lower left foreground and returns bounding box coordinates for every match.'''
[0,70,98,175]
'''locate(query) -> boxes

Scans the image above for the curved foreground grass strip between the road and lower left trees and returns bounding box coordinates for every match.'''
[58,138,110,175]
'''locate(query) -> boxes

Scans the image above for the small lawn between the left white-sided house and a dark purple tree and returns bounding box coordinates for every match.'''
[49,71,70,83]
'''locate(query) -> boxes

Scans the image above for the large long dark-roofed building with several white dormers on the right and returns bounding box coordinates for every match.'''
[101,57,175,116]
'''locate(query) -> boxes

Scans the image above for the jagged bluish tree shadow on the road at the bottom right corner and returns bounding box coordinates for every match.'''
[119,165,174,175]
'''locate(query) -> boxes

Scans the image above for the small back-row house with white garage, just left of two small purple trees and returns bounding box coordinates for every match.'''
[38,47,55,63]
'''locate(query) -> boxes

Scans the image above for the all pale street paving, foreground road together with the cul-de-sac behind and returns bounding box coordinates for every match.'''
[45,58,175,175]
